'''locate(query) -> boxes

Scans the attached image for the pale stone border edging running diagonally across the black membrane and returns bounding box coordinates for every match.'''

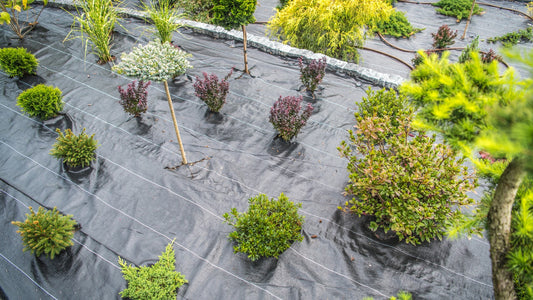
[36,0,405,88]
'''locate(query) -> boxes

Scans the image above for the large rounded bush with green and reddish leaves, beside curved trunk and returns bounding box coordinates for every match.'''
[339,91,476,245]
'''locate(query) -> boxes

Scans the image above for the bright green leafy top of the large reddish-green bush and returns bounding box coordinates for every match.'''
[354,87,413,130]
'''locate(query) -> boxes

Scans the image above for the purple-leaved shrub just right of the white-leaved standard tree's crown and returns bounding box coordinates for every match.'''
[194,69,233,112]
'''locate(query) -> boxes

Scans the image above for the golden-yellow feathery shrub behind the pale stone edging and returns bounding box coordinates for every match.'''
[268,0,394,62]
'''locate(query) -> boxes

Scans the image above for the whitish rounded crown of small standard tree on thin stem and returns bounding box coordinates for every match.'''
[113,40,192,81]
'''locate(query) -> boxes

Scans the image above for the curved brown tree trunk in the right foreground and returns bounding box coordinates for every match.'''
[488,158,525,300]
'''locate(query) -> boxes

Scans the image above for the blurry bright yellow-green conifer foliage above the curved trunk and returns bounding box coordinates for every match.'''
[400,52,514,147]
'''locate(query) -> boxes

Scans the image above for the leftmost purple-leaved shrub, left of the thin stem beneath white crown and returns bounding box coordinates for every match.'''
[118,80,151,117]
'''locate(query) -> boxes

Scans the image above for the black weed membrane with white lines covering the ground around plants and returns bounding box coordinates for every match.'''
[4,2,525,299]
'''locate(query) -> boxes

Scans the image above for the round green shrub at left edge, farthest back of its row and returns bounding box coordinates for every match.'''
[0,47,39,78]
